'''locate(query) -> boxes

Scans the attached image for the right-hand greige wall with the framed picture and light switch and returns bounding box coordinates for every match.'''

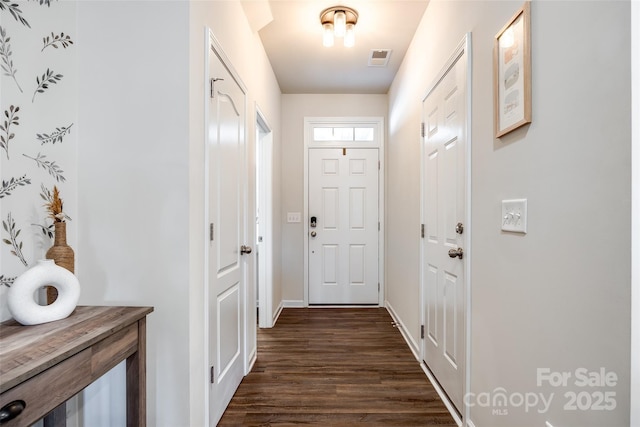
[386,0,631,426]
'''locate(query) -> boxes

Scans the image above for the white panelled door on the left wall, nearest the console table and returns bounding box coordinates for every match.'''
[207,36,246,426]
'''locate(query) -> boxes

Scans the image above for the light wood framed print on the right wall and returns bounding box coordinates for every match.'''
[493,1,531,138]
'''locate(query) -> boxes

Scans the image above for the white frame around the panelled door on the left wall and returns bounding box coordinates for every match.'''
[202,27,250,425]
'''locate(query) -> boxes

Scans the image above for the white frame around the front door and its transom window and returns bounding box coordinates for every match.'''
[302,116,386,307]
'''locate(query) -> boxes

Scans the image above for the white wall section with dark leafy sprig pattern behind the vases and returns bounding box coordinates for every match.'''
[0,0,78,321]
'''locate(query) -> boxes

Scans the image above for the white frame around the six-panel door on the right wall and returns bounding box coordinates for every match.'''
[420,33,473,425]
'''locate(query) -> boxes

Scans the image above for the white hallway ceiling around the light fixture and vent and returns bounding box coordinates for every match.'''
[243,0,428,93]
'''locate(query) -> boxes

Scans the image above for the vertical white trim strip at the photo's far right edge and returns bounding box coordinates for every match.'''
[630,1,640,427]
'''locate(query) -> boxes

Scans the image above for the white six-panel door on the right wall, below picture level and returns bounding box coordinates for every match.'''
[421,41,468,412]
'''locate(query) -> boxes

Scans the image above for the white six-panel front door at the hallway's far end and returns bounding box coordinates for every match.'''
[307,148,379,304]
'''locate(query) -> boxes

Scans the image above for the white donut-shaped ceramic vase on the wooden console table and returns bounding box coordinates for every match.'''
[7,259,80,325]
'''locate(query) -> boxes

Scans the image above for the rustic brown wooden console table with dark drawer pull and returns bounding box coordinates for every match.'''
[0,306,153,427]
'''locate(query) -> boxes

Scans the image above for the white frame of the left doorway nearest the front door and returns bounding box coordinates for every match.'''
[255,103,273,328]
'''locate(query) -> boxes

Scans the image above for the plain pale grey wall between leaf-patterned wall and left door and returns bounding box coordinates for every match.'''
[77,1,190,426]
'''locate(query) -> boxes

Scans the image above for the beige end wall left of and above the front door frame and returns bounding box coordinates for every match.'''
[282,94,388,305]
